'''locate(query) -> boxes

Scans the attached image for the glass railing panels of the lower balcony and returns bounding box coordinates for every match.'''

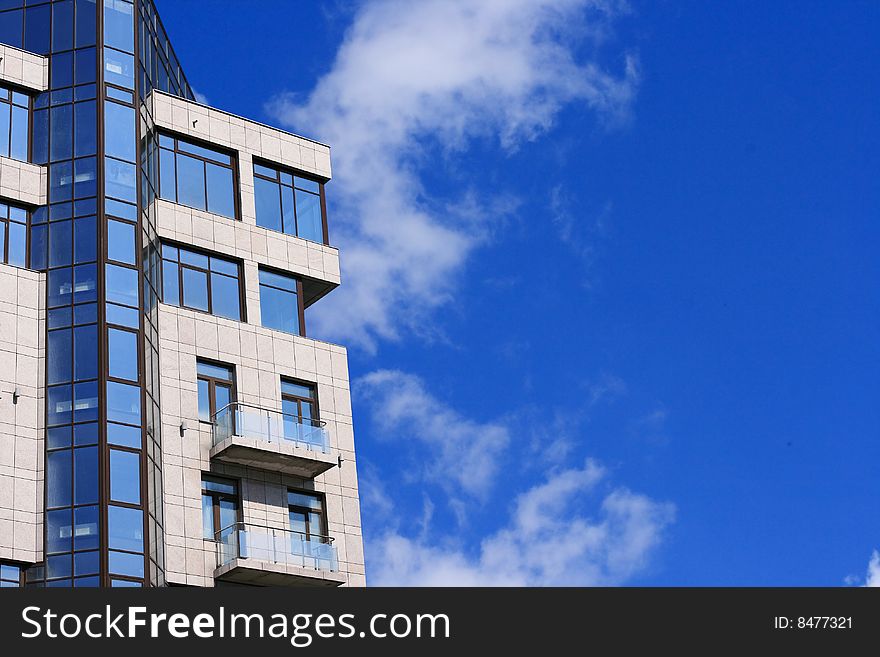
[216,522,339,571]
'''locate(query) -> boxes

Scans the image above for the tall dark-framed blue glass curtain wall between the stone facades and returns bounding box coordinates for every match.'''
[0,0,193,587]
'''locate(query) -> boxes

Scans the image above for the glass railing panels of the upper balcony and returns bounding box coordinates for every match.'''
[214,402,330,454]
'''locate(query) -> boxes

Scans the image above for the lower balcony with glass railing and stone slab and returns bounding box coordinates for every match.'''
[214,522,345,586]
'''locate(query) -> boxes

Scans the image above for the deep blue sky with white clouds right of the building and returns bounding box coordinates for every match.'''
[157,0,880,585]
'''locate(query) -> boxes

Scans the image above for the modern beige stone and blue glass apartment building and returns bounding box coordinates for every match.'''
[0,0,365,587]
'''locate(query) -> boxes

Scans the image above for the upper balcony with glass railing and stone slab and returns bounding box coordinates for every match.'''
[211,402,339,479]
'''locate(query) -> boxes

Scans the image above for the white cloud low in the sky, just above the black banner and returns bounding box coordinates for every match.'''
[368,460,675,586]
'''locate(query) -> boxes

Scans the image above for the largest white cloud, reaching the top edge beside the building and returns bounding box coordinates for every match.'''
[269,0,638,349]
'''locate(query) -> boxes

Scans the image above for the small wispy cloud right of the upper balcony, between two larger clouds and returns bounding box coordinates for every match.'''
[354,370,510,496]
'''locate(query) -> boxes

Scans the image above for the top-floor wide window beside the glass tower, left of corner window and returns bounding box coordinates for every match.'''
[159,135,236,219]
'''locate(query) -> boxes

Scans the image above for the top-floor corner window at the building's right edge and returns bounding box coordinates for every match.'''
[254,163,326,244]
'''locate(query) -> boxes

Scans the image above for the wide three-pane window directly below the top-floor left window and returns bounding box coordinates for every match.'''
[162,244,241,320]
